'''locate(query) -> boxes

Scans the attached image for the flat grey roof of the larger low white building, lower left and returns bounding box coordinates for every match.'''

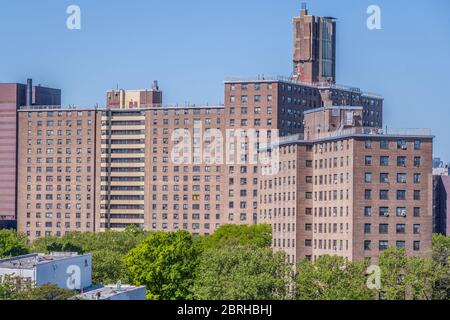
[0,252,86,269]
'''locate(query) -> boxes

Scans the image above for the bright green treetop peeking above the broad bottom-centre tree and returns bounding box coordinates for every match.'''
[200,224,272,249]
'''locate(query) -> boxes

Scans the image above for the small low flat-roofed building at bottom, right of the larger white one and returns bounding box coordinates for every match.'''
[74,284,147,300]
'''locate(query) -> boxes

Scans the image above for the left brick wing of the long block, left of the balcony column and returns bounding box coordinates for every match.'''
[17,106,100,239]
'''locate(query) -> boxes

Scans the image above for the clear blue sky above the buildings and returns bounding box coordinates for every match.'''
[0,0,450,161]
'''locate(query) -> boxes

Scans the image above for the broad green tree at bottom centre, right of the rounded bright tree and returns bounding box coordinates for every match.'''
[194,246,292,300]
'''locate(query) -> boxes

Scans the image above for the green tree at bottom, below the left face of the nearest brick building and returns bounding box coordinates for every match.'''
[296,255,374,300]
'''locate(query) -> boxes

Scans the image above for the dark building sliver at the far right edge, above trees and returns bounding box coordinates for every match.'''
[433,175,450,236]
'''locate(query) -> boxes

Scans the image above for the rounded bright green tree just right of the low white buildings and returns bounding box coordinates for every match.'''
[124,231,200,300]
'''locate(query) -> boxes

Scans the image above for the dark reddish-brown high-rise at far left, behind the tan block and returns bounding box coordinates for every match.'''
[0,79,61,227]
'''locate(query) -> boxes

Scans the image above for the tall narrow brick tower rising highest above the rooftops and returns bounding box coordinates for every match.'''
[293,3,336,83]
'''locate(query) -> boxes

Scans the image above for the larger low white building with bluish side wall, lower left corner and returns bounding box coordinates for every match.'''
[0,252,92,290]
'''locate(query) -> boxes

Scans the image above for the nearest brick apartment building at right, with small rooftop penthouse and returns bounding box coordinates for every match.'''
[258,107,433,262]
